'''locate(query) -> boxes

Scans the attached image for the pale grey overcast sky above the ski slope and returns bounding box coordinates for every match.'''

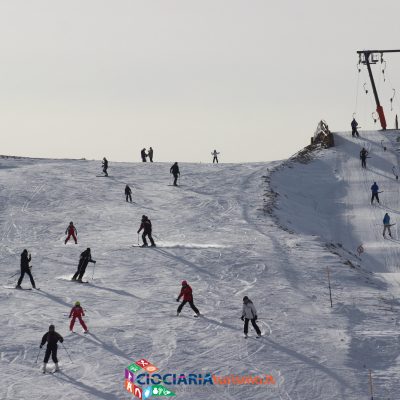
[0,0,400,162]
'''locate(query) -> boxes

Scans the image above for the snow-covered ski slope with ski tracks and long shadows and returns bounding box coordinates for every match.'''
[0,132,400,400]
